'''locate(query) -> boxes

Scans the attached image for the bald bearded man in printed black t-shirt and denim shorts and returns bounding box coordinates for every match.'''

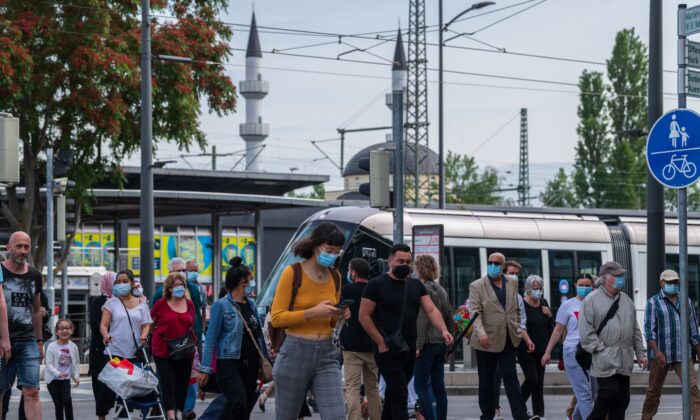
[0,232,44,420]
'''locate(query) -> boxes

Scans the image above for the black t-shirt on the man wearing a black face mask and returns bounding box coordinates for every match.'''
[362,274,428,349]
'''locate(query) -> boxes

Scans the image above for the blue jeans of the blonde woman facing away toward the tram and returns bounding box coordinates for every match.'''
[413,344,447,420]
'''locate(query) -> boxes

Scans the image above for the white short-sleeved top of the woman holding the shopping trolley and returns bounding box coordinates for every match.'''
[102,297,153,359]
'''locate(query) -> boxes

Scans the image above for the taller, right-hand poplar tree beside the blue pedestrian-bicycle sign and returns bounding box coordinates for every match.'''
[607,29,648,208]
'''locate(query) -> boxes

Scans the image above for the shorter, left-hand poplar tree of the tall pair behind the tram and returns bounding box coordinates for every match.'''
[572,70,611,208]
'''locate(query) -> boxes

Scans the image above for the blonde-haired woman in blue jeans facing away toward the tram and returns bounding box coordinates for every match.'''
[413,255,454,420]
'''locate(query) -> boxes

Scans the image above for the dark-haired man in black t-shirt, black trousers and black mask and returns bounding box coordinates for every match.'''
[359,244,453,420]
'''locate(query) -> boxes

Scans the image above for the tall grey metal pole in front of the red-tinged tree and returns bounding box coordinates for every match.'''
[140,0,155,297]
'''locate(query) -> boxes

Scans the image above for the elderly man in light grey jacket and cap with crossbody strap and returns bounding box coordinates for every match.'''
[579,261,647,420]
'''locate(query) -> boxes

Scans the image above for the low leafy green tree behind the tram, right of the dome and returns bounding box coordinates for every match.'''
[445,151,502,204]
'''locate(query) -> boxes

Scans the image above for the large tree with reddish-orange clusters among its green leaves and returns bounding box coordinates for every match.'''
[0,0,236,267]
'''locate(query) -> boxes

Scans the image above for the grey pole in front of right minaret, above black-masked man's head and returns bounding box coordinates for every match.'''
[392,89,404,244]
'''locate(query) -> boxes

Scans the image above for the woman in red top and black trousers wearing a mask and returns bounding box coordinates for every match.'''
[151,273,195,419]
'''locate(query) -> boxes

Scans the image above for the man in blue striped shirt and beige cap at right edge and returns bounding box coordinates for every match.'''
[642,270,700,420]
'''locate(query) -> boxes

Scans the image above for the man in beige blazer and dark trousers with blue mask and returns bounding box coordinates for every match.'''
[467,253,538,420]
